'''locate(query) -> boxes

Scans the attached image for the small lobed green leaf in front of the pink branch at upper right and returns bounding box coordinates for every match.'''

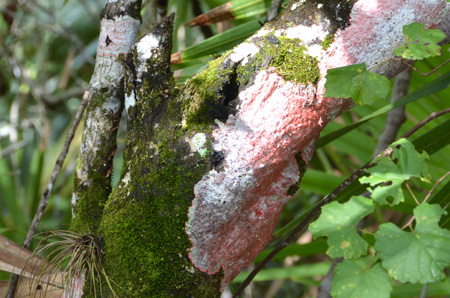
[394,23,445,60]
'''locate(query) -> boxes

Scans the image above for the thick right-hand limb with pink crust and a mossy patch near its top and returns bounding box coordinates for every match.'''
[181,0,449,292]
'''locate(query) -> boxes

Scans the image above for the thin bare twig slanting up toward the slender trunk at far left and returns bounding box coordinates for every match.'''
[6,91,89,298]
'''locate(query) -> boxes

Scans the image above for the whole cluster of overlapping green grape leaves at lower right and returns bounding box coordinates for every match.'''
[309,139,450,298]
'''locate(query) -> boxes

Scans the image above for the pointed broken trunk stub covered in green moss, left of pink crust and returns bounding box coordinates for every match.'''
[100,16,221,297]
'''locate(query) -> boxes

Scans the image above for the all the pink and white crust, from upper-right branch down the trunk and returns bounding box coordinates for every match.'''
[186,0,448,285]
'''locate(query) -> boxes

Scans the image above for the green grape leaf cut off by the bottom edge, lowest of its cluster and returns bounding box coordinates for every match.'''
[331,256,392,298]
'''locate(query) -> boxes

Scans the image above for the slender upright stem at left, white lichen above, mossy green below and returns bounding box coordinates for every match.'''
[72,0,141,234]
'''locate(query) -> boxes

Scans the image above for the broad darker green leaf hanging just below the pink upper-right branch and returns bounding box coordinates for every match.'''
[325,64,391,105]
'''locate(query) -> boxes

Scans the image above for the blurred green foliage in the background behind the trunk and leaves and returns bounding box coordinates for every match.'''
[0,0,450,297]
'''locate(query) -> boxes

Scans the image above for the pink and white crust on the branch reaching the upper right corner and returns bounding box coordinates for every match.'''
[321,0,447,75]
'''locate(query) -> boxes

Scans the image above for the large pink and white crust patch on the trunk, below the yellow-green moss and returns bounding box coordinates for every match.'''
[186,69,352,285]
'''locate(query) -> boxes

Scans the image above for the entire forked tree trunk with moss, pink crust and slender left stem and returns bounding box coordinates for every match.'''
[73,0,450,297]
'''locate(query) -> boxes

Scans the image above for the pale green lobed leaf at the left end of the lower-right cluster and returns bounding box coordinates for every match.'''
[309,196,374,259]
